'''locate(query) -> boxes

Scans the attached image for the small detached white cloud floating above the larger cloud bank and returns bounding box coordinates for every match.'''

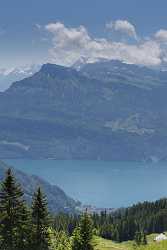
[106,20,137,40]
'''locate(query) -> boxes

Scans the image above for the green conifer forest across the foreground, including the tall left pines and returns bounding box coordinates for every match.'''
[0,169,167,250]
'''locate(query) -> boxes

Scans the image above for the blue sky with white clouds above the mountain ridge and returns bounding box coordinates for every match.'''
[0,0,167,69]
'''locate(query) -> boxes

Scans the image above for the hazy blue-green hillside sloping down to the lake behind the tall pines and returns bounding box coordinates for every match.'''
[0,161,79,213]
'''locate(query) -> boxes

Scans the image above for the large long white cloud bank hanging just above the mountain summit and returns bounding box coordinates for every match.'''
[45,22,162,66]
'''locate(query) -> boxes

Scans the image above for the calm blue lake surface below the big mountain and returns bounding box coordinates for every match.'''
[5,160,167,208]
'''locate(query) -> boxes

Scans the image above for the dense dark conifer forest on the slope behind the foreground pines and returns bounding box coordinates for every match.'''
[54,199,167,242]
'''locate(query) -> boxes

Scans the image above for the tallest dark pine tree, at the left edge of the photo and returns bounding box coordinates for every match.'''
[0,169,29,250]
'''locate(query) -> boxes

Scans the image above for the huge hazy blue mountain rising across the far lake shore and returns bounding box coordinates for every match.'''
[0,61,167,160]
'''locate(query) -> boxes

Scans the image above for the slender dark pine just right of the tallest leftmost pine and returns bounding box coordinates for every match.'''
[31,188,50,250]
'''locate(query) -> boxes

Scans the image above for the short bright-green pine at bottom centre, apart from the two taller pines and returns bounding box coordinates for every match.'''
[72,211,93,250]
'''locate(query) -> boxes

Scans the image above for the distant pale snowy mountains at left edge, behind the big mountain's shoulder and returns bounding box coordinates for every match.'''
[0,65,40,91]
